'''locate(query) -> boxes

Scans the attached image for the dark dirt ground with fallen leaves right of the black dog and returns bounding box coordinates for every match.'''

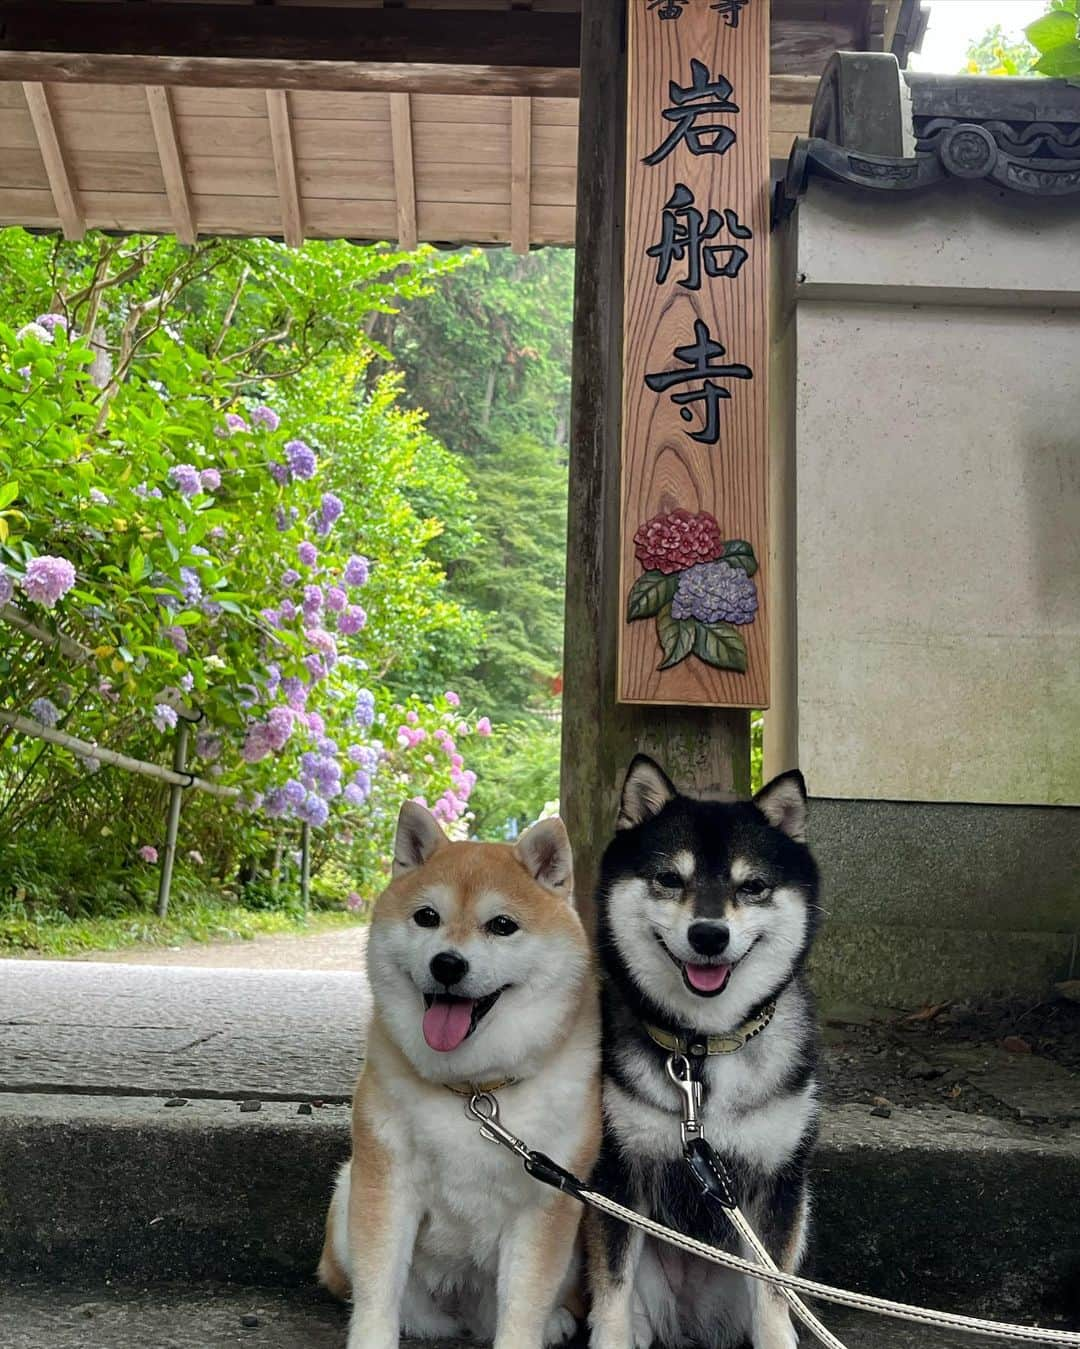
[822,994,1080,1132]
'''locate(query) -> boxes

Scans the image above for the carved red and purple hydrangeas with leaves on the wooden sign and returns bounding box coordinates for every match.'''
[627,510,758,672]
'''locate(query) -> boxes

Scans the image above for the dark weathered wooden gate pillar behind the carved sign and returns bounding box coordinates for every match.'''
[561,0,750,920]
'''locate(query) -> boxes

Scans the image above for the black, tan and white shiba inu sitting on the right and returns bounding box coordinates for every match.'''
[589,755,820,1349]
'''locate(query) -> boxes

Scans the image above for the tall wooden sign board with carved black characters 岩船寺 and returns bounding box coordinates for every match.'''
[619,0,769,708]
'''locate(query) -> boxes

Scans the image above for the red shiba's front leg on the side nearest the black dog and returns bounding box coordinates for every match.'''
[495,1194,581,1349]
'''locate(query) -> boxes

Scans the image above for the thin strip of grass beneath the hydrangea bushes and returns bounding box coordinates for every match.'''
[0,900,357,955]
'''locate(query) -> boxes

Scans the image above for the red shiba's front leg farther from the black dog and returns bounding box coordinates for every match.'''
[348,1093,421,1349]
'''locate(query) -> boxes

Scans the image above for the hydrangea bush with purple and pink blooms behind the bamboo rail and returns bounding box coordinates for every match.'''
[0,232,489,898]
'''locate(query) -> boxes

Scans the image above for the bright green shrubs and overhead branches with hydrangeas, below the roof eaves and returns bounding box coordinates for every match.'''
[0,231,501,938]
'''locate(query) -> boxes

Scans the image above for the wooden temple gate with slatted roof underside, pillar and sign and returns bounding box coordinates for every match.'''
[0,0,921,893]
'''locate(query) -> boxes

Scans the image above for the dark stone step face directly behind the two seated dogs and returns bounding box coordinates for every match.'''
[0,1093,1080,1322]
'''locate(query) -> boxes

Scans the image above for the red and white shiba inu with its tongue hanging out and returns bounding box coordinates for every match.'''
[320,803,600,1349]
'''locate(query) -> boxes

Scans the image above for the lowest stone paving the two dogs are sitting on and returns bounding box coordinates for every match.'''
[0,1286,1067,1349]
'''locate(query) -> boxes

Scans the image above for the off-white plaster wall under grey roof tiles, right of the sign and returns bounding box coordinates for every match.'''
[796,188,1080,804]
